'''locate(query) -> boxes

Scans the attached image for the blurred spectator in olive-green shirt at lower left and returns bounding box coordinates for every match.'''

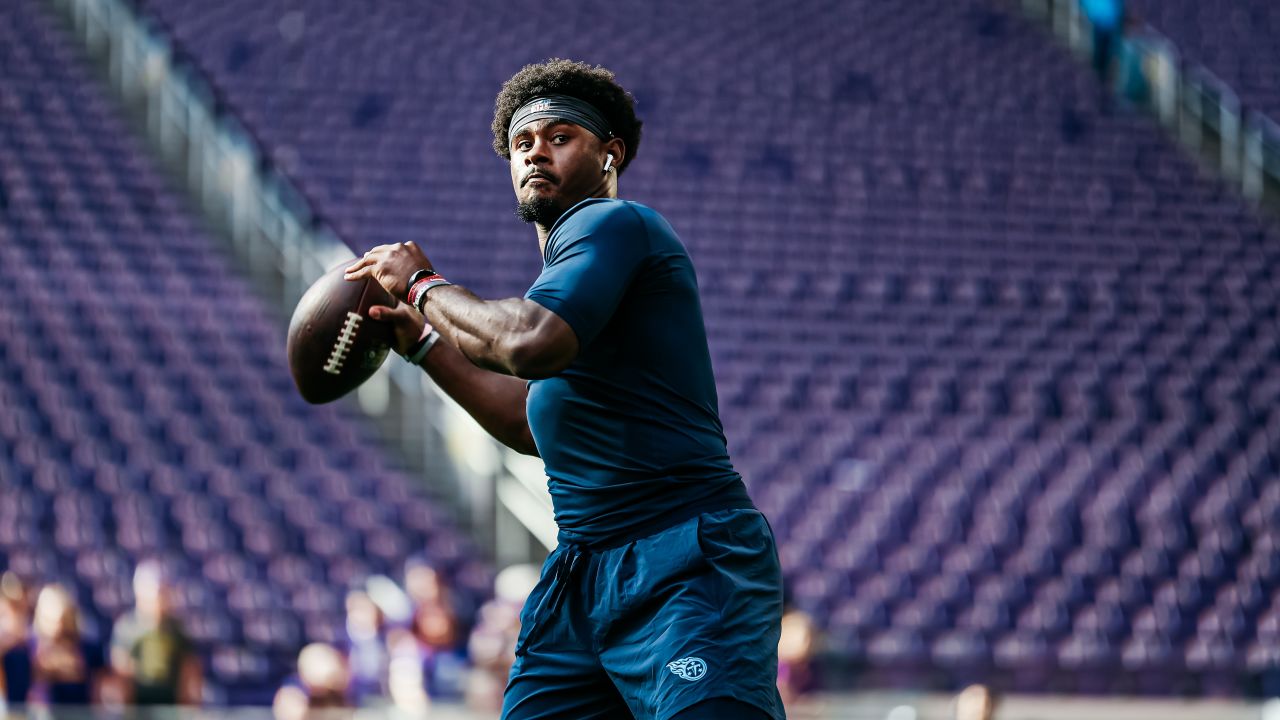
[111,560,204,706]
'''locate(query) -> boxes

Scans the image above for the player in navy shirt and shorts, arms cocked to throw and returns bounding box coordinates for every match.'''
[347,60,783,720]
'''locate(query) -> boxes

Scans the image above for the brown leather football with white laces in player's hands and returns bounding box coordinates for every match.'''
[285,263,396,404]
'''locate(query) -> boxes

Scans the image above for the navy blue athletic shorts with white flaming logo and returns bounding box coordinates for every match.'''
[502,510,786,720]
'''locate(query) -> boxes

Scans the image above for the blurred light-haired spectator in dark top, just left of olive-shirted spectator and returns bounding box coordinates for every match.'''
[31,584,104,705]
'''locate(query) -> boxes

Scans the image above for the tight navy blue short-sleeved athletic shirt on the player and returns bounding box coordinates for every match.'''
[525,199,750,543]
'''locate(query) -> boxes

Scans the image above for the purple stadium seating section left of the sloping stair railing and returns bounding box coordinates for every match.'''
[0,0,489,702]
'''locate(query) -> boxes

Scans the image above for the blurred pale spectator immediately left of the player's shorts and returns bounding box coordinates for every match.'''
[466,565,538,710]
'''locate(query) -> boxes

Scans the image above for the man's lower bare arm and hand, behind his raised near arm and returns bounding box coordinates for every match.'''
[370,302,538,456]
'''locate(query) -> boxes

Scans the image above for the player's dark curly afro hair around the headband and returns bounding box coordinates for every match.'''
[493,59,643,174]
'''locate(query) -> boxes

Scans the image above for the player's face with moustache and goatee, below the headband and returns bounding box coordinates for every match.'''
[511,119,607,227]
